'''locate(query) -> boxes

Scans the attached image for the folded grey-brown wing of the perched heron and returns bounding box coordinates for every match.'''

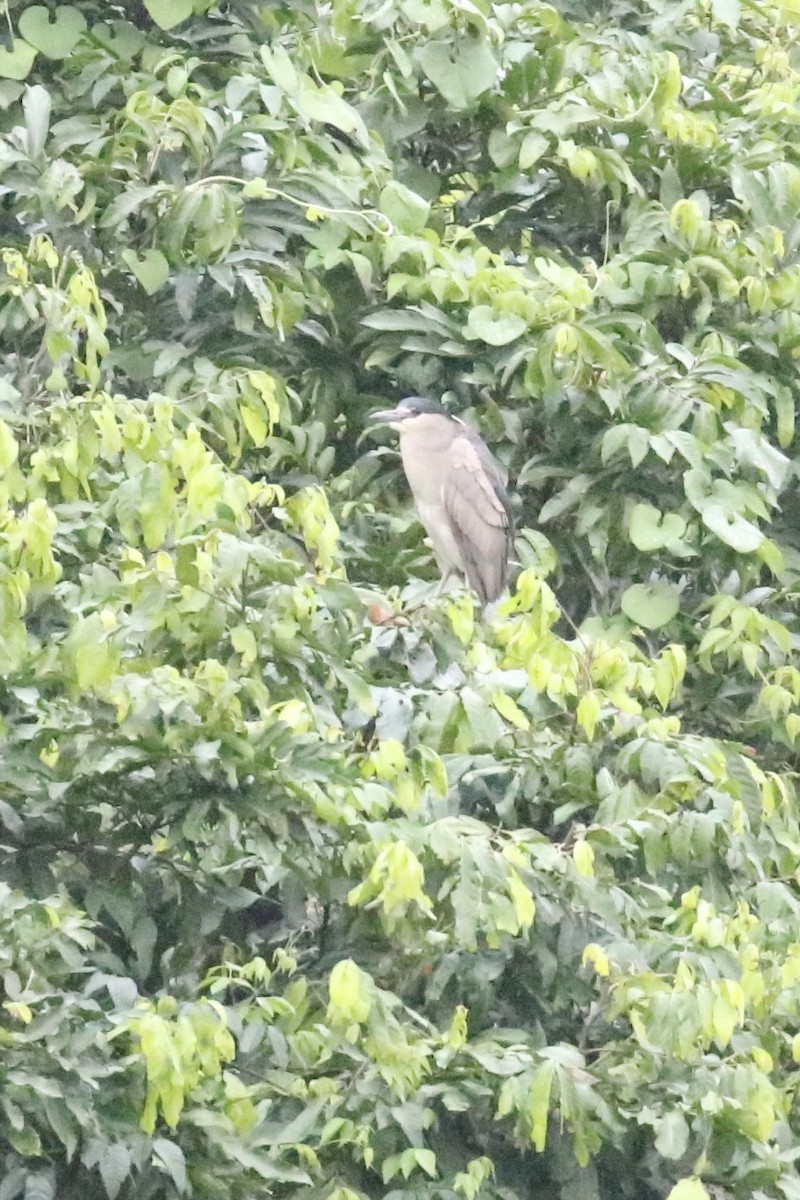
[441,430,513,604]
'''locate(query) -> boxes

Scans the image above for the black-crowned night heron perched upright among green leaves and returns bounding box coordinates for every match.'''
[372,396,513,605]
